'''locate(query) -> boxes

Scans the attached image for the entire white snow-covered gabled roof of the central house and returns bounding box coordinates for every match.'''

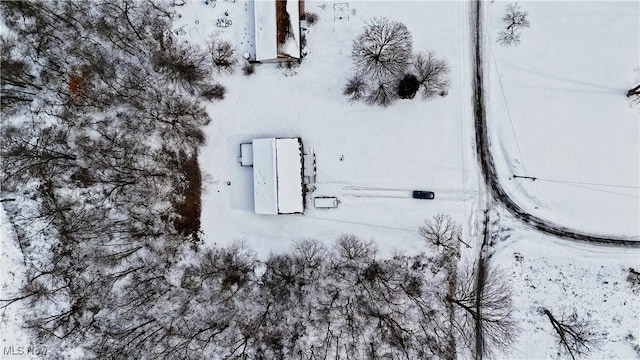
[253,138,304,215]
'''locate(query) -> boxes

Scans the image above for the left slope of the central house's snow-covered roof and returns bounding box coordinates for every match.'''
[253,139,278,215]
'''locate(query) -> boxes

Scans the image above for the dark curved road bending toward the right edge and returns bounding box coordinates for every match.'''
[470,0,640,248]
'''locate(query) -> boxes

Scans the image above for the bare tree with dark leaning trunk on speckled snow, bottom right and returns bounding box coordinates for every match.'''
[538,307,600,360]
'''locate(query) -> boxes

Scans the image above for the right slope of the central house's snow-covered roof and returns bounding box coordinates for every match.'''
[275,139,304,214]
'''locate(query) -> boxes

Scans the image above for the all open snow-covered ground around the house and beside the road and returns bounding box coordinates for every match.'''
[0,0,640,359]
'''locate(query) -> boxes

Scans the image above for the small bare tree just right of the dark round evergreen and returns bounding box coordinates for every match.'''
[413,52,450,100]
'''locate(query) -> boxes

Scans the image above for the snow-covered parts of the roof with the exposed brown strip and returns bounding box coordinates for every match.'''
[253,0,300,61]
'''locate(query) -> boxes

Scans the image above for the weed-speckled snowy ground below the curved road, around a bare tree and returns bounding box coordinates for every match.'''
[492,210,640,360]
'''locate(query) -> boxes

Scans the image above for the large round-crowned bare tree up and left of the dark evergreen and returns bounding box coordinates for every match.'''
[351,17,413,80]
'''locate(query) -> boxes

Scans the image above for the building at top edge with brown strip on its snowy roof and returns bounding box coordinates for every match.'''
[253,0,300,61]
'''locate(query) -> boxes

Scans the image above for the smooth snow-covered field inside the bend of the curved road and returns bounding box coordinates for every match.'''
[486,1,640,237]
